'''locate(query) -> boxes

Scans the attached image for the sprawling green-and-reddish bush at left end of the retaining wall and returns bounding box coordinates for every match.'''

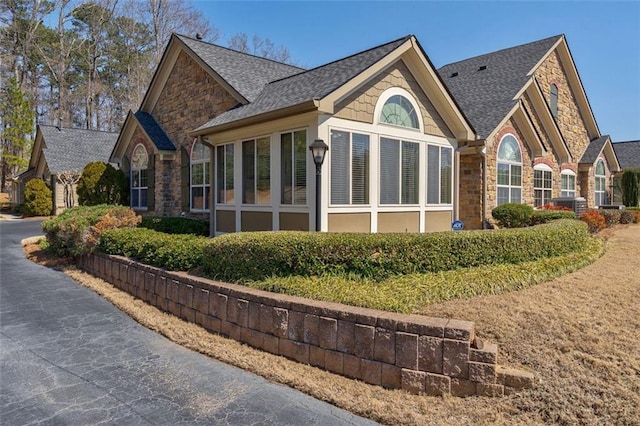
[42,205,140,256]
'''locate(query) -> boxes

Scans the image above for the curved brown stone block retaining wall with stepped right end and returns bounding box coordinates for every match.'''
[80,254,533,396]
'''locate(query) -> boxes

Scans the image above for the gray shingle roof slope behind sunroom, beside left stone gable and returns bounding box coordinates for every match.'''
[176,34,304,102]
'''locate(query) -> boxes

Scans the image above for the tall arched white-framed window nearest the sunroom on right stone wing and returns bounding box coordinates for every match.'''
[497,134,522,205]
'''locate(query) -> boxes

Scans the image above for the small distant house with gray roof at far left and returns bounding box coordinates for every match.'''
[13,125,118,214]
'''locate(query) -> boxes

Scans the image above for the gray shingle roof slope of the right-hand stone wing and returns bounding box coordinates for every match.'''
[438,35,562,139]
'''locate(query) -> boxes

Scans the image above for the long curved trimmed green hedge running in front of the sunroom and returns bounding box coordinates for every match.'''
[203,220,589,282]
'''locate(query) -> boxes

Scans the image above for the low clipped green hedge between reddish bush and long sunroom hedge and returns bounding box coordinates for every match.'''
[99,228,209,271]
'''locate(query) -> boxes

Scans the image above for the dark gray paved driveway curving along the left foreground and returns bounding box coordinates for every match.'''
[0,220,373,426]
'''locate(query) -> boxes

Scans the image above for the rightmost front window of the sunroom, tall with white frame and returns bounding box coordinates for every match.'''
[427,145,453,204]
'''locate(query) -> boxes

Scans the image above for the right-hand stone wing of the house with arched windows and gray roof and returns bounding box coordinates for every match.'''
[438,35,620,228]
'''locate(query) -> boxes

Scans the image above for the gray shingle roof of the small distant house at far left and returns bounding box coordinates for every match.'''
[39,125,118,174]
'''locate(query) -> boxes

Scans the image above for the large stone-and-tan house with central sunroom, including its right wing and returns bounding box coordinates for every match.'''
[111,34,620,235]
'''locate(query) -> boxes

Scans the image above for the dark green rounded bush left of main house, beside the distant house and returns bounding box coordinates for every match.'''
[77,161,129,206]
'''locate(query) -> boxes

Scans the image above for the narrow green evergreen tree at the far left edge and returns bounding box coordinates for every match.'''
[0,77,34,192]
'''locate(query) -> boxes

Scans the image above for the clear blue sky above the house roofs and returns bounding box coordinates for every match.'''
[193,0,640,141]
